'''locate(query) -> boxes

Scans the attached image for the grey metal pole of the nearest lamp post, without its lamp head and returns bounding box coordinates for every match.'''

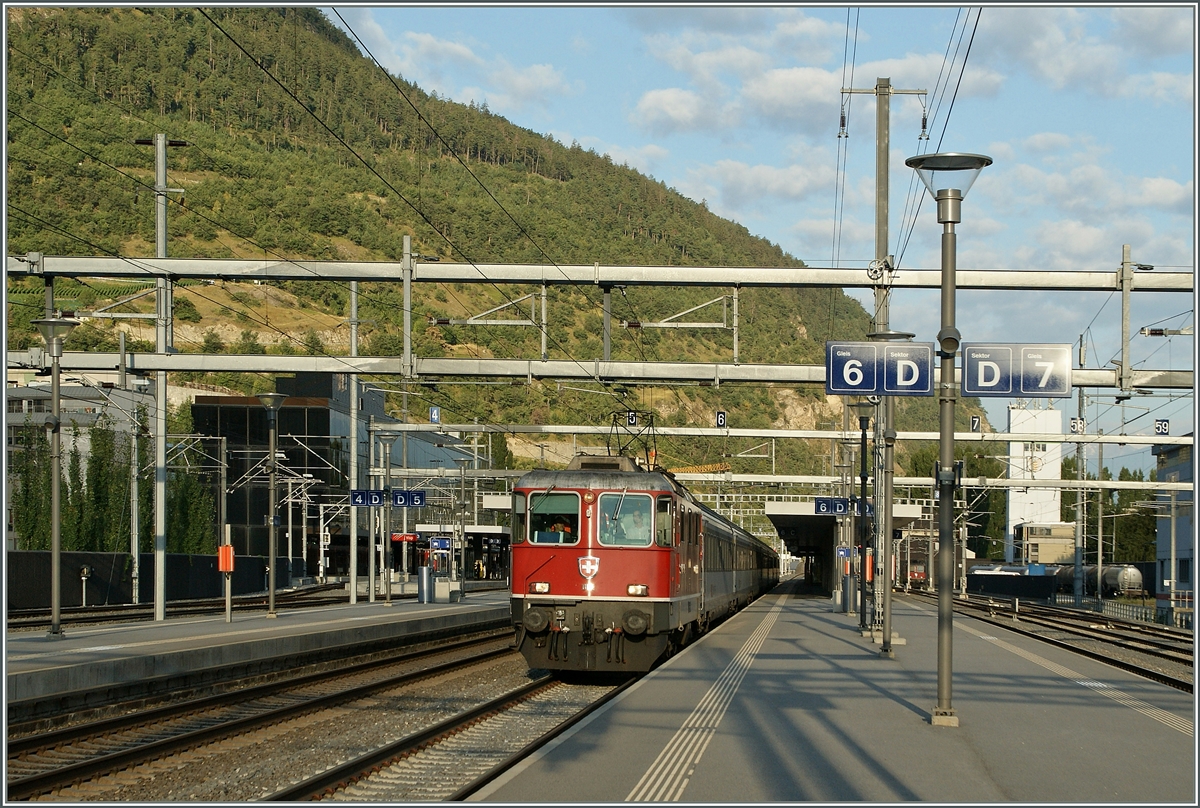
[932,188,962,726]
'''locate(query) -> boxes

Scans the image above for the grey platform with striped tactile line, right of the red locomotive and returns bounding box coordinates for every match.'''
[470,582,1198,806]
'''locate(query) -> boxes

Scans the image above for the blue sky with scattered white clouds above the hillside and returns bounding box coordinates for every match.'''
[326,6,1196,468]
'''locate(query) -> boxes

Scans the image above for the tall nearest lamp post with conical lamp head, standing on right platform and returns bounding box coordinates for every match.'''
[904,151,991,726]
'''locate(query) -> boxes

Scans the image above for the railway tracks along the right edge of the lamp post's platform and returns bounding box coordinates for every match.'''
[910,592,1195,693]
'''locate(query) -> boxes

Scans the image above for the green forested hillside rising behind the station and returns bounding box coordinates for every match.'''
[6,7,1003,547]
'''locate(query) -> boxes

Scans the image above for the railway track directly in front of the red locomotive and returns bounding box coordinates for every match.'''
[264,675,637,802]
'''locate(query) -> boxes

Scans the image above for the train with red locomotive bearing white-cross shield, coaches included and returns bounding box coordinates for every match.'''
[511,456,779,672]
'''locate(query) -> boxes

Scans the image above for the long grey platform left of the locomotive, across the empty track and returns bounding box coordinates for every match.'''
[5,589,510,722]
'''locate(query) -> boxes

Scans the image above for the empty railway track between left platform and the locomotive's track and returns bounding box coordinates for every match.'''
[6,632,512,801]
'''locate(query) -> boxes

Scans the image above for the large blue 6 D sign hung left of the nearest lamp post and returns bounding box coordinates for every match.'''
[826,342,934,396]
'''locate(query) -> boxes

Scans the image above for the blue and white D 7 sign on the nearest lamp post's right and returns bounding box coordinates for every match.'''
[962,342,1070,399]
